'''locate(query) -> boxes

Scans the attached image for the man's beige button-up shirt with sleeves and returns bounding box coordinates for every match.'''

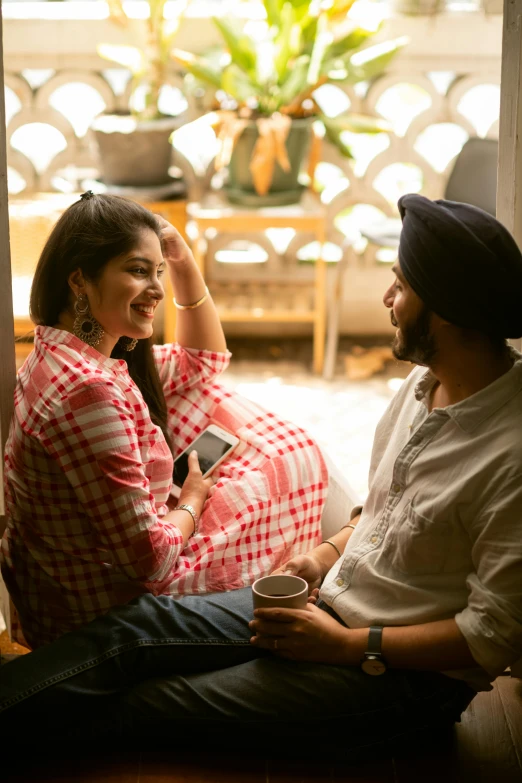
[321,351,522,690]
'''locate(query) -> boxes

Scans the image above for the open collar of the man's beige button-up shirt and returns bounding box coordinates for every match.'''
[415,348,522,433]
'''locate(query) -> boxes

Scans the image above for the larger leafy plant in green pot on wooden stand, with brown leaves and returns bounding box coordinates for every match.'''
[172,0,406,206]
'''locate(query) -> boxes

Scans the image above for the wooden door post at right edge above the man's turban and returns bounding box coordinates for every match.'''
[497,0,522,350]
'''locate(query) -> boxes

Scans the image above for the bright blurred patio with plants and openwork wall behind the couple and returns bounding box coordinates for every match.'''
[2,0,502,495]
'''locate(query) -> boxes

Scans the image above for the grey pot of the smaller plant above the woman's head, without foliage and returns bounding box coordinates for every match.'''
[91,114,182,187]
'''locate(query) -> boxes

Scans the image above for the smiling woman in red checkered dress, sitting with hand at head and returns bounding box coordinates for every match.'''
[1,192,334,647]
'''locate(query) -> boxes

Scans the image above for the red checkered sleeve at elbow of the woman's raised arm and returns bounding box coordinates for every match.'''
[152,343,231,400]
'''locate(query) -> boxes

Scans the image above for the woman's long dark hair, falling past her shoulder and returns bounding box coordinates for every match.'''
[30,194,170,454]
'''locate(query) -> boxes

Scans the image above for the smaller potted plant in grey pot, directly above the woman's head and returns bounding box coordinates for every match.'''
[91,0,188,190]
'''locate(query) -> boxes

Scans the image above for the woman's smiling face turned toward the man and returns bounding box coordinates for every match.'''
[79,229,165,355]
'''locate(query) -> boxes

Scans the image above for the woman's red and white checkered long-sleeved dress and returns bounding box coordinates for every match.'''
[0,327,328,647]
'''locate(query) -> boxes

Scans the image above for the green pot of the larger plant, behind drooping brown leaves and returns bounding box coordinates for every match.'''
[225,117,313,207]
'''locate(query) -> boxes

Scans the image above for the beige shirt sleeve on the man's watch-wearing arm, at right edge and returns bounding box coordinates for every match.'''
[455,476,522,678]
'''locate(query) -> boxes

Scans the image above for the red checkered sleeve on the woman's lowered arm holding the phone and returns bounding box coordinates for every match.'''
[41,381,184,594]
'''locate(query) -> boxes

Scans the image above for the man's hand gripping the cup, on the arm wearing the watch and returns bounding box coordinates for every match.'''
[249,604,350,665]
